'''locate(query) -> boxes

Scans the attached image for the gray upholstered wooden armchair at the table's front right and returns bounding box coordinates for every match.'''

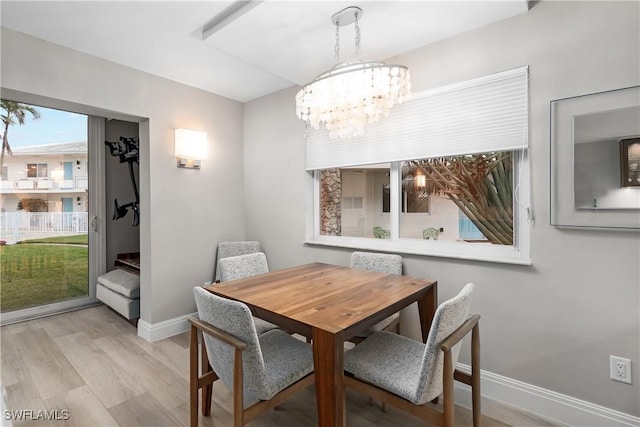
[345,283,480,427]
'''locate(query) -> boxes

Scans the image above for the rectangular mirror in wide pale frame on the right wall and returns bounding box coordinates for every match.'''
[550,86,640,229]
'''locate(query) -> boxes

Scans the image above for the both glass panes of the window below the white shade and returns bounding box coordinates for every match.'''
[320,151,514,245]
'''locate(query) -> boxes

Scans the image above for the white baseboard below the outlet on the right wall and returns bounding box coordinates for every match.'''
[456,363,640,427]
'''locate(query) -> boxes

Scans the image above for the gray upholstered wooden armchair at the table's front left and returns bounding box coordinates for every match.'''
[189,287,315,427]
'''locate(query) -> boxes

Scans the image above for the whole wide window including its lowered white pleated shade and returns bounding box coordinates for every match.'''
[307,67,530,264]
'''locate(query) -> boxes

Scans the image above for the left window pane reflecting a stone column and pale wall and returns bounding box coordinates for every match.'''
[319,165,390,237]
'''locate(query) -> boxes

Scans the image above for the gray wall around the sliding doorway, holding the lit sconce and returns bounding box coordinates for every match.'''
[1,28,244,325]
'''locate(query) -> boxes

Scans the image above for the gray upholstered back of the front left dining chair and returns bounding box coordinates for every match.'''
[193,287,271,401]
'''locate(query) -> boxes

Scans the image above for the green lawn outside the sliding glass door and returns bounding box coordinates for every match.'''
[0,236,89,312]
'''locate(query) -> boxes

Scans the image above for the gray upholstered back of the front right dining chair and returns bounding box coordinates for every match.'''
[417,283,475,403]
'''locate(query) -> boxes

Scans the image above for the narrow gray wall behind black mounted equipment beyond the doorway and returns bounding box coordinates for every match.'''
[104,120,140,270]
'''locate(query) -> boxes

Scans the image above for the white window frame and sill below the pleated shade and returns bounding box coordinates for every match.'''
[305,149,532,265]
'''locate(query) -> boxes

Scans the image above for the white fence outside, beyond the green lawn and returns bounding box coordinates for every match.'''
[0,212,89,243]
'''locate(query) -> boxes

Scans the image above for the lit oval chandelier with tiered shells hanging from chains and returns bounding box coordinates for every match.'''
[296,6,411,139]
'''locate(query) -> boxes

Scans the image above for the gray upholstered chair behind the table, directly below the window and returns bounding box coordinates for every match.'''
[349,252,402,343]
